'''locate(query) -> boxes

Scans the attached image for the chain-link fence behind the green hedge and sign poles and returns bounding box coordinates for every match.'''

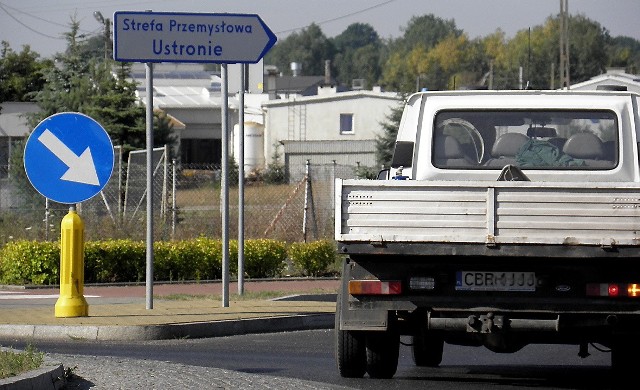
[0,148,370,244]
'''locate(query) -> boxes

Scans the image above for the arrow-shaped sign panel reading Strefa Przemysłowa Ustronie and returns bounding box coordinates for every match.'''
[113,11,277,64]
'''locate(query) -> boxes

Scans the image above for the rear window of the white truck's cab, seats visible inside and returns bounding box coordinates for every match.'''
[432,110,618,170]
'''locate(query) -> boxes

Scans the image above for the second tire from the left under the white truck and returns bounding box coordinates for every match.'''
[366,328,400,379]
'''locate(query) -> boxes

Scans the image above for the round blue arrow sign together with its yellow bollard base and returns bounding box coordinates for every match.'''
[24,112,114,317]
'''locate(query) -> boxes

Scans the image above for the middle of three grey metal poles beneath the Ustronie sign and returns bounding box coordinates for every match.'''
[220,64,229,307]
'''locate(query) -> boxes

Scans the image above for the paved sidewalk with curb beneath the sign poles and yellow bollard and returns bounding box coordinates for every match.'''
[0,279,339,340]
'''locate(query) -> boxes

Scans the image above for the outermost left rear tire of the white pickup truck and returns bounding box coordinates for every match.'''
[335,294,367,378]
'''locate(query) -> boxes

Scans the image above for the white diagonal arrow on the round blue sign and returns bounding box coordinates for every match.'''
[38,129,100,186]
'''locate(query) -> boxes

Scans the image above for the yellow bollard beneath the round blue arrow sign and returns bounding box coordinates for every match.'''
[55,207,89,317]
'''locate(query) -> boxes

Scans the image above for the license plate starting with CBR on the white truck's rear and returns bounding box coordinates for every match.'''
[456,271,536,291]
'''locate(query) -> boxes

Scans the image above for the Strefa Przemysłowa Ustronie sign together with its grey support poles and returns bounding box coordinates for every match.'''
[113,11,277,308]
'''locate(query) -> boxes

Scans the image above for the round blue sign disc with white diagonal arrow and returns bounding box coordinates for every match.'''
[24,112,114,204]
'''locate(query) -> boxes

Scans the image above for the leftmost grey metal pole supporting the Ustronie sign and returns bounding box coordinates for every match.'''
[145,62,153,309]
